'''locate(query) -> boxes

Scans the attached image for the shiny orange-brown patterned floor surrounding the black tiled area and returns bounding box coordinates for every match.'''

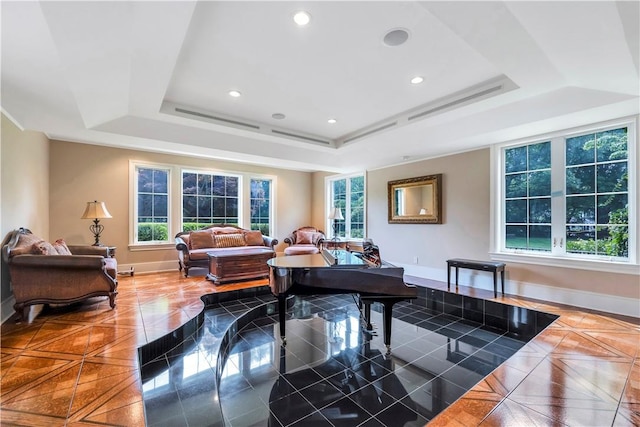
[0,272,640,426]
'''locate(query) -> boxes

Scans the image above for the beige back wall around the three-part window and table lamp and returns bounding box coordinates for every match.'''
[50,141,311,270]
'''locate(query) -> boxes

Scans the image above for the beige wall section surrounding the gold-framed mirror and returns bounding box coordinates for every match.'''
[367,150,490,269]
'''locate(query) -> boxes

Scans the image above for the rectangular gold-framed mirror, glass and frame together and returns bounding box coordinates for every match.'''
[387,174,442,224]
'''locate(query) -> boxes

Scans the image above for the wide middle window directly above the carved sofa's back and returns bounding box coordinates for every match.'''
[182,171,240,231]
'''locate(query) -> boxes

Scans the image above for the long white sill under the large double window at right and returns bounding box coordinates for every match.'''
[489,252,640,276]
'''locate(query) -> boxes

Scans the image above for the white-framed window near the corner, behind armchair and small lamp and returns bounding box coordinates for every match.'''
[327,174,366,239]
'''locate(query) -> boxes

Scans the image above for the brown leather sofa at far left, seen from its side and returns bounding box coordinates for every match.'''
[2,228,118,320]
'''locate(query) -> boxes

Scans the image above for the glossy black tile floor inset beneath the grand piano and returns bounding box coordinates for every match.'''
[142,290,551,427]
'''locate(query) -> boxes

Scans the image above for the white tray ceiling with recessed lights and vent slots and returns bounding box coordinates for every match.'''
[0,0,640,172]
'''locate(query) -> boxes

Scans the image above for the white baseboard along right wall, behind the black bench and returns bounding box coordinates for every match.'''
[391,261,640,318]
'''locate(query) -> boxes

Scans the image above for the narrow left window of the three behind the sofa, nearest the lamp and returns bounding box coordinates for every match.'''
[134,165,169,243]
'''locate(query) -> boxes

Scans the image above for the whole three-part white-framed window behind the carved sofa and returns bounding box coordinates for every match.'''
[129,160,277,246]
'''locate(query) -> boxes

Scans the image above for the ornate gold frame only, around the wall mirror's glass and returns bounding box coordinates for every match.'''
[387,174,442,224]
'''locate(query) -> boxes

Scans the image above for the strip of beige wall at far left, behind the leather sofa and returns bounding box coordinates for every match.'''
[0,114,49,314]
